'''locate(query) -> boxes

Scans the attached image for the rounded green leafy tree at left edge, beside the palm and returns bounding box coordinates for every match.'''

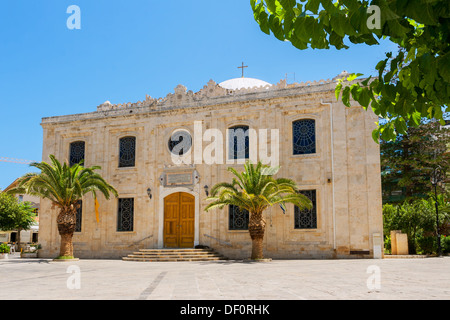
[0,193,36,231]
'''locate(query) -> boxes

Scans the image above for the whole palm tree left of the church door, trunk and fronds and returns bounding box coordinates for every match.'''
[9,155,118,257]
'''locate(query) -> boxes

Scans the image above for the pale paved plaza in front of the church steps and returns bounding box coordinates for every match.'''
[0,257,450,300]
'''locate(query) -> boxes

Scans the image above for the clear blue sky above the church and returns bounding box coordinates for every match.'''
[0,0,396,189]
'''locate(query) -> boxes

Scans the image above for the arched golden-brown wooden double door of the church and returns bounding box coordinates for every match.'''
[164,192,195,248]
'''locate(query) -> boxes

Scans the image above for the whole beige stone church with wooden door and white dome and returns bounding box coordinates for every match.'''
[39,74,383,259]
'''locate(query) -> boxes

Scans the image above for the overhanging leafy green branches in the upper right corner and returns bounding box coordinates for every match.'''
[250,0,450,140]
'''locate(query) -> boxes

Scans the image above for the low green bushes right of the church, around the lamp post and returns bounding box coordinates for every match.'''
[383,195,450,254]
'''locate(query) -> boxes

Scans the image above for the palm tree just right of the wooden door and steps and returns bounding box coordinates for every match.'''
[205,162,312,260]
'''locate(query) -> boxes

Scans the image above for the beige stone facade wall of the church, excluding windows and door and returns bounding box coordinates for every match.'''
[39,78,383,258]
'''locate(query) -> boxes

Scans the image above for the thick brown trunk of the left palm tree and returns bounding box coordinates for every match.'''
[56,205,77,257]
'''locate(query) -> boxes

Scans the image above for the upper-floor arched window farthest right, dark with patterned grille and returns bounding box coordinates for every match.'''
[292,119,316,154]
